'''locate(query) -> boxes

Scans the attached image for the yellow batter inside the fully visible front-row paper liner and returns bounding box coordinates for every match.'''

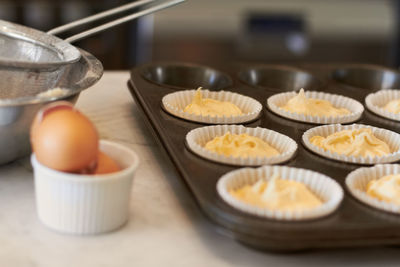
[230,174,322,211]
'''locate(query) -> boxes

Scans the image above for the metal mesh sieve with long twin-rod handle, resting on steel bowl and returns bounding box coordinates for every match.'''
[0,0,185,71]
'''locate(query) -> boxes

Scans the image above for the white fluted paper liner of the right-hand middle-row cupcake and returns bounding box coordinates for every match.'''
[302,124,400,165]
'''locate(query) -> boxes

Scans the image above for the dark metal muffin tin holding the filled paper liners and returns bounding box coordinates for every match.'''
[128,62,400,251]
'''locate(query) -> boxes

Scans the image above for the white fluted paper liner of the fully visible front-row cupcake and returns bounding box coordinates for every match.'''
[217,166,343,221]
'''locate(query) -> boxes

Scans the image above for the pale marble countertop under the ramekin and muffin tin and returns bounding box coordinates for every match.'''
[0,71,400,267]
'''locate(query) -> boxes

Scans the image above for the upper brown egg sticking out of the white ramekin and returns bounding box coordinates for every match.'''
[31,101,99,172]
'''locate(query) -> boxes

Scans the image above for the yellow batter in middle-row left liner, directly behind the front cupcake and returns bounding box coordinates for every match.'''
[205,132,280,158]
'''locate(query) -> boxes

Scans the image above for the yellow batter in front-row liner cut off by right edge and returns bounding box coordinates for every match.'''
[367,174,400,205]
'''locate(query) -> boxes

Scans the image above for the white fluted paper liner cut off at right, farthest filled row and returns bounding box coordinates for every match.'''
[365,90,400,121]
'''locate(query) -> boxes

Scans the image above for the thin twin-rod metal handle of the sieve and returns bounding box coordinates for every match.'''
[47,0,186,43]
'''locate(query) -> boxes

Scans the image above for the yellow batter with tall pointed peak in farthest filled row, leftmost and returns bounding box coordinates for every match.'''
[183,87,243,117]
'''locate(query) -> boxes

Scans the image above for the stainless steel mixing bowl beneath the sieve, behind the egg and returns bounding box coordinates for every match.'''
[0,50,103,164]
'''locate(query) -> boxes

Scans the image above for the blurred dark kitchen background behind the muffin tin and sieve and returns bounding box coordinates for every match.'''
[0,0,400,69]
